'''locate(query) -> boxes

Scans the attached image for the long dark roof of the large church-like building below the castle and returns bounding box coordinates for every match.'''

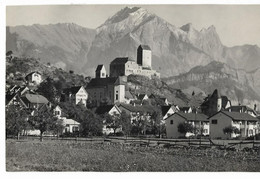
[87,77,124,88]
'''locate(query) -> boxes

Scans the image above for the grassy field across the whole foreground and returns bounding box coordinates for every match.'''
[6,140,260,172]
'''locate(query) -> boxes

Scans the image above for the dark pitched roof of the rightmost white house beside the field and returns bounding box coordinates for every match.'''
[209,111,258,121]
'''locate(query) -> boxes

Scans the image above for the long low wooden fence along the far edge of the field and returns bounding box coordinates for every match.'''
[7,136,260,150]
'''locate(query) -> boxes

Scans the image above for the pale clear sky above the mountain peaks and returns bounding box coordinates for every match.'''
[6,4,260,47]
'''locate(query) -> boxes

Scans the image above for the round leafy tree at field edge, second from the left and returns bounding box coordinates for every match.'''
[29,109,61,141]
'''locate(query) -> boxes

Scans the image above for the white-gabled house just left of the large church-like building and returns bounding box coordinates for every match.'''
[62,86,88,106]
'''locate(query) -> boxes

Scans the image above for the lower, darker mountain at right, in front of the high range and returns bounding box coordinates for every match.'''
[164,61,260,107]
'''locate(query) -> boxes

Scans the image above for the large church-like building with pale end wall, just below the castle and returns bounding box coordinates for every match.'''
[86,72,126,106]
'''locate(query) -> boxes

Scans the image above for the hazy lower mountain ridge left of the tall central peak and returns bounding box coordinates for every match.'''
[6,23,95,71]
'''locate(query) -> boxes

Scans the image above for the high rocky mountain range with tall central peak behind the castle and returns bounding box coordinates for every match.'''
[7,7,260,77]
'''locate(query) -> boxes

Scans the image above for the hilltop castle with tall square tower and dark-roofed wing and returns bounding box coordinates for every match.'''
[110,45,160,78]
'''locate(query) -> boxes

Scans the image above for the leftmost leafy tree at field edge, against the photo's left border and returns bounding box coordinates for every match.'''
[6,105,30,140]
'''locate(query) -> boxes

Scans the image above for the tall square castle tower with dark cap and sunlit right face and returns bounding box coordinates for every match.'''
[137,45,152,69]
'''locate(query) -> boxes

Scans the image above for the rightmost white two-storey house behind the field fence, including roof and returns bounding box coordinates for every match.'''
[209,111,259,139]
